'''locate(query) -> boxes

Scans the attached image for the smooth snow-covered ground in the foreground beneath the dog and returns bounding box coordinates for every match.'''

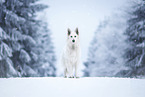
[0,77,145,97]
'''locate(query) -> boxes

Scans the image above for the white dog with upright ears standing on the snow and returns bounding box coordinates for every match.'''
[62,28,80,78]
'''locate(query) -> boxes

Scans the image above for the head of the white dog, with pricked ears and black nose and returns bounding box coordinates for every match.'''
[68,28,79,44]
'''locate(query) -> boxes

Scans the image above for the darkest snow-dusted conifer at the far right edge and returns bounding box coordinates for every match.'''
[125,0,145,77]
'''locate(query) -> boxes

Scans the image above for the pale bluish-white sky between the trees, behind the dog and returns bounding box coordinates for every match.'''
[38,0,127,73]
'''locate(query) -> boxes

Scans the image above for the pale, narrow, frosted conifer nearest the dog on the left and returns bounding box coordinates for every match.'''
[34,22,56,76]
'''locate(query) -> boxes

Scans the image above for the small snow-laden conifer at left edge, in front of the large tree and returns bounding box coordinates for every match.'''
[0,27,18,77]
